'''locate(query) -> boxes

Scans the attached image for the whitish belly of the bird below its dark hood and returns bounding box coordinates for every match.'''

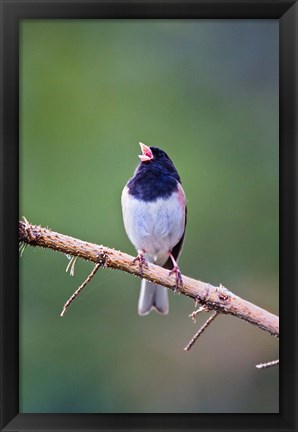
[121,187,185,265]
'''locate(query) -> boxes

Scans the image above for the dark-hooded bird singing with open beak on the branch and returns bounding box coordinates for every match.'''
[121,142,187,316]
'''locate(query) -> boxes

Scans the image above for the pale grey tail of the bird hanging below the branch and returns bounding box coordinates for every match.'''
[138,279,169,315]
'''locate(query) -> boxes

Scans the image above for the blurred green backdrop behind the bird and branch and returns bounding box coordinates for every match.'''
[20,20,279,413]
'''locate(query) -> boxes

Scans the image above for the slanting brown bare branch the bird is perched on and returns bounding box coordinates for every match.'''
[19,219,279,337]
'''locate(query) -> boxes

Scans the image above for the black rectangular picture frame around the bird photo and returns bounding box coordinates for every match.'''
[0,0,298,431]
